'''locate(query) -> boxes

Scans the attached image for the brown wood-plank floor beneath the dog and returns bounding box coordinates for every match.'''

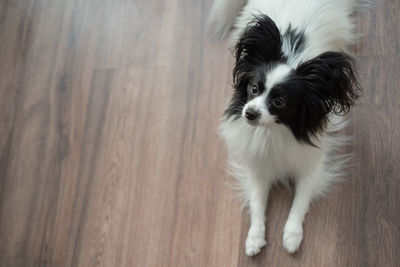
[0,0,400,267]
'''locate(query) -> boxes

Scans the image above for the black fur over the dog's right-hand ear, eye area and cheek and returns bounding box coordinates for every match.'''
[267,52,361,145]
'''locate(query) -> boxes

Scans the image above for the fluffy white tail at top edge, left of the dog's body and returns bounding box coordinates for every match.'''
[208,0,247,38]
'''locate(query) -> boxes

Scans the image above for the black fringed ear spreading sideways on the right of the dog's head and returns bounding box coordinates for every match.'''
[296,52,361,114]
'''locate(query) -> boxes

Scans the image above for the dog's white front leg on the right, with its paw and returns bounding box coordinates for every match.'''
[283,163,326,253]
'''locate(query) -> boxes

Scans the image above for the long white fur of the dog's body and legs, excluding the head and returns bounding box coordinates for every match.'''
[210,0,358,256]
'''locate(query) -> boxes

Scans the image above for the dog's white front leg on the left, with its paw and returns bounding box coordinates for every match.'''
[246,176,270,256]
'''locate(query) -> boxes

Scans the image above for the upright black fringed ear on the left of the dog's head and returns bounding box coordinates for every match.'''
[233,15,283,88]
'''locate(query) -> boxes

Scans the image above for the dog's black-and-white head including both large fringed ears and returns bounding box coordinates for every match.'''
[225,16,359,144]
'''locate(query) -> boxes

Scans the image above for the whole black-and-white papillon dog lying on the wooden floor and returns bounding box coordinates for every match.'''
[210,0,361,256]
